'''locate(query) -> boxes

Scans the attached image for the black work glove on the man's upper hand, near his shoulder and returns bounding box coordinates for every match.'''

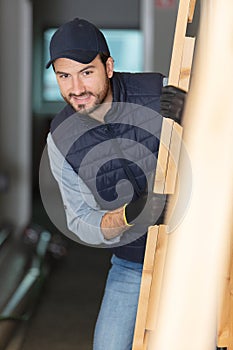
[160,85,187,124]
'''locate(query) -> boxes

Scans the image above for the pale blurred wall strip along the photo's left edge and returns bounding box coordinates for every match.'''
[0,0,32,228]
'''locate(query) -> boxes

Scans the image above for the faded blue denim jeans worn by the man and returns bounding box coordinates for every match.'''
[93,255,142,350]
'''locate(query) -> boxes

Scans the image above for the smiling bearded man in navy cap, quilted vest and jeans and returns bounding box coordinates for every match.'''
[47,18,186,350]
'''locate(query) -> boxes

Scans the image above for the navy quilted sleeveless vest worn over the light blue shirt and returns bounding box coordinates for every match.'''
[51,73,162,262]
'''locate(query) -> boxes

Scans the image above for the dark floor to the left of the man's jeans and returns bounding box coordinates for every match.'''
[6,200,111,350]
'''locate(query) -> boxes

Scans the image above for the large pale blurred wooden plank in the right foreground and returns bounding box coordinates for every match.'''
[148,0,233,344]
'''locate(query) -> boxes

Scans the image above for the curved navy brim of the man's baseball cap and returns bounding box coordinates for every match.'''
[45,50,98,68]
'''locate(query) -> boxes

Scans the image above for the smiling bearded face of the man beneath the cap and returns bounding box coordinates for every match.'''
[54,55,113,114]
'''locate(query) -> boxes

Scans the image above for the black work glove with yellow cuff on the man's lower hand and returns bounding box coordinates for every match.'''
[125,192,167,226]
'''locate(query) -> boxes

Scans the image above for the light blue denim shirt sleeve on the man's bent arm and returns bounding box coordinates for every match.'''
[47,133,120,245]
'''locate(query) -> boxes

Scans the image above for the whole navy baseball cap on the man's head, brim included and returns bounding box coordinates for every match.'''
[46,18,110,68]
